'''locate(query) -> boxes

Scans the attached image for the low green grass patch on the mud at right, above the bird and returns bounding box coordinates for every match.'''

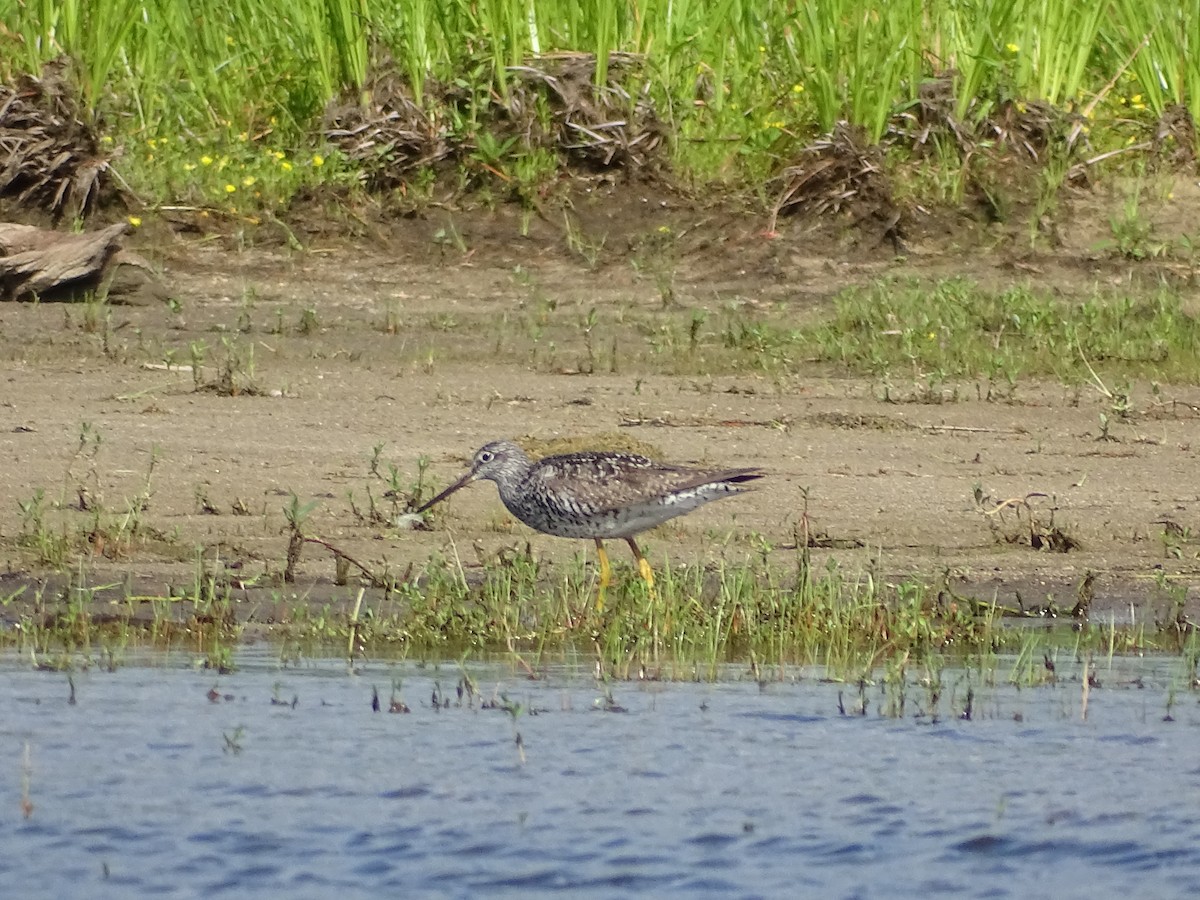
[794,278,1200,384]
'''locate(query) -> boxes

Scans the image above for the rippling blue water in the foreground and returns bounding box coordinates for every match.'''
[0,654,1200,898]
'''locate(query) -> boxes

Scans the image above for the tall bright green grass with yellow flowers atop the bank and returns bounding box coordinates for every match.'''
[0,0,1200,211]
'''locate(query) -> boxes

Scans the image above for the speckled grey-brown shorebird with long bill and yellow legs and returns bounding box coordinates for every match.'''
[416,440,764,608]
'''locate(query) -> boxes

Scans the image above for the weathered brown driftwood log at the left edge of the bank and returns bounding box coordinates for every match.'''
[0,222,156,301]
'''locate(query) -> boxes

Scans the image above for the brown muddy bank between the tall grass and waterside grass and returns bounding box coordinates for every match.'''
[0,186,1200,620]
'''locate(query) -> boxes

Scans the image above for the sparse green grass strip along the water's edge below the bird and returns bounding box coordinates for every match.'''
[2,535,1195,683]
